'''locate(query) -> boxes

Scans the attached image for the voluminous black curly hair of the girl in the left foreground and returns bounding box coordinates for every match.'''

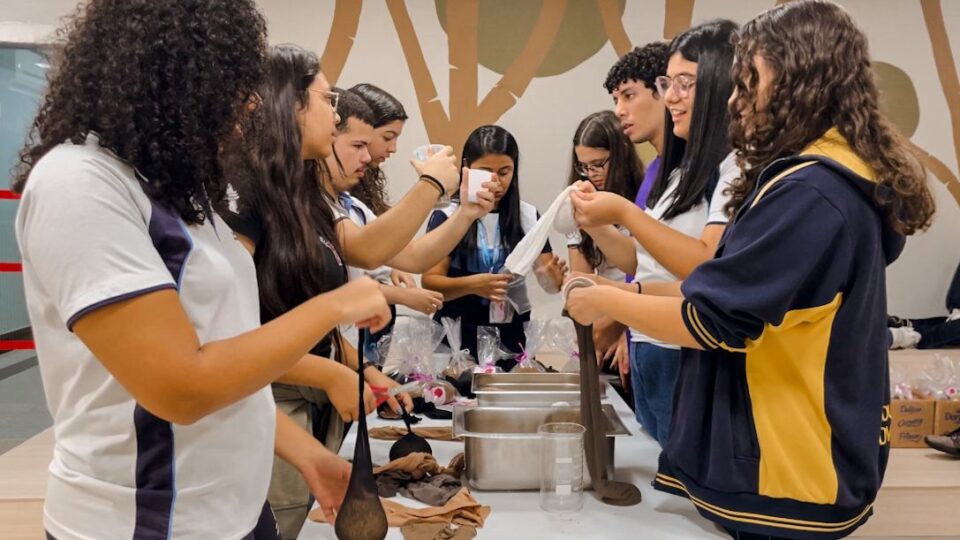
[13,0,266,224]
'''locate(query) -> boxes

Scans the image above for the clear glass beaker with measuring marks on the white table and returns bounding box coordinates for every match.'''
[537,422,586,513]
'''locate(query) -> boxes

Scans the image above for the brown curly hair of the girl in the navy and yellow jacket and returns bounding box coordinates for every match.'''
[728,0,934,235]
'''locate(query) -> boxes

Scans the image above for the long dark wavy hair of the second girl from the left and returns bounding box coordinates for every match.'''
[253,45,342,321]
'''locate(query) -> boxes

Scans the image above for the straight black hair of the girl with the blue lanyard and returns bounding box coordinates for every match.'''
[455,126,523,260]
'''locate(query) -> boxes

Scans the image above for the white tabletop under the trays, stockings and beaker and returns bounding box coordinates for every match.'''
[300,389,729,540]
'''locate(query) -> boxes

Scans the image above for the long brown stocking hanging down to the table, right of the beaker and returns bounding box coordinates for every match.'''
[574,321,642,506]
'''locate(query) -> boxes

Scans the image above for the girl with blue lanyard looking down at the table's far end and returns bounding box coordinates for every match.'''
[423,126,566,357]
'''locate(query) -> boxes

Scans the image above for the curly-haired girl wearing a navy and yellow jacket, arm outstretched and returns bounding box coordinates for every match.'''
[568,1,934,539]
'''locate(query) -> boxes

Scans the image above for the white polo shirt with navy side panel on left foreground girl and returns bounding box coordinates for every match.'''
[16,136,275,540]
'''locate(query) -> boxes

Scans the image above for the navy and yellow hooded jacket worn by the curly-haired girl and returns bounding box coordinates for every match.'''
[654,129,904,538]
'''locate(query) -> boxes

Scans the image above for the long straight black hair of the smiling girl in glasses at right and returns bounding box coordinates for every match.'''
[647,19,738,219]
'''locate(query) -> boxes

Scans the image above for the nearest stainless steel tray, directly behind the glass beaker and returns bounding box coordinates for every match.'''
[453,404,630,491]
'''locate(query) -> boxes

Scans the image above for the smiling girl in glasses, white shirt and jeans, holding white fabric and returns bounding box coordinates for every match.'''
[573,21,740,444]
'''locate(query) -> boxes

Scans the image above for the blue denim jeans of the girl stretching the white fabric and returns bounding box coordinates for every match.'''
[630,342,680,446]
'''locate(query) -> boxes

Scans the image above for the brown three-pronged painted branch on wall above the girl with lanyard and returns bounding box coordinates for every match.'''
[387,0,567,149]
